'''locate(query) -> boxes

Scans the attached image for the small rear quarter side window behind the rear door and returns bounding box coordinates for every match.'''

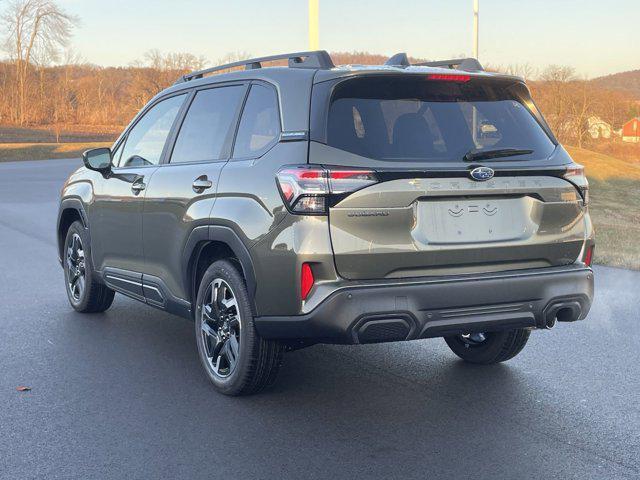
[233,85,280,158]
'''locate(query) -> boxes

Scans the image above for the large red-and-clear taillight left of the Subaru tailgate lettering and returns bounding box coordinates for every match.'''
[276,167,378,215]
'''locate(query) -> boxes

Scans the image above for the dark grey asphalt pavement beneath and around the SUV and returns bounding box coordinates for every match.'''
[0,161,640,479]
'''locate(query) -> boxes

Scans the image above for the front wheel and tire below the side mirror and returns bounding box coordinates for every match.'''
[62,221,115,313]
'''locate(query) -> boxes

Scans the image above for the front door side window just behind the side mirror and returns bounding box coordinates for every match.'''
[119,94,186,167]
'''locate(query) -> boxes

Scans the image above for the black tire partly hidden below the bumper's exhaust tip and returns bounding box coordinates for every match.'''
[444,328,531,365]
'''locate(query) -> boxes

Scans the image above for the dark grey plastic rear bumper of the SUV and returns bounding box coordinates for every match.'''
[255,264,593,343]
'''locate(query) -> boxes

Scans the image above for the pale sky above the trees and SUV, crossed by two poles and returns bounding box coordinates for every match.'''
[60,0,640,77]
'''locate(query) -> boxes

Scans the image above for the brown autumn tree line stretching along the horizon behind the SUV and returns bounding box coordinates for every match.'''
[0,0,640,150]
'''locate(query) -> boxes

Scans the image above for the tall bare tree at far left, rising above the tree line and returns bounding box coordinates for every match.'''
[0,0,77,125]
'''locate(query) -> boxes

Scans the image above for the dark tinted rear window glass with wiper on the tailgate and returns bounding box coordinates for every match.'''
[327,77,555,162]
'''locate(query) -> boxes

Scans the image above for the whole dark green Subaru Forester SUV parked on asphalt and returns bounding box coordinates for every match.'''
[57,51,594,395]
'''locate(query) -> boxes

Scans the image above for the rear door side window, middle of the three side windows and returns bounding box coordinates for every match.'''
[171,85,245,163]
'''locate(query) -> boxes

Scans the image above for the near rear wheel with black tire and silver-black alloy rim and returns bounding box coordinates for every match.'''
[195,260,283,395]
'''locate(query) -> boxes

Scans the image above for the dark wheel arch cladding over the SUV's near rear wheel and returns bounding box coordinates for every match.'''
[183,226,257,315]
